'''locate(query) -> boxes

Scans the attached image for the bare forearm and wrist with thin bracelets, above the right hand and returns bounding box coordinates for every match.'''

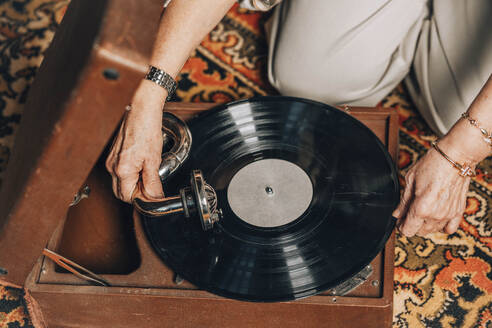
[439,75,492,164]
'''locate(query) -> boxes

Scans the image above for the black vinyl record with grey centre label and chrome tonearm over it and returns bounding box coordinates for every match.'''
[135,97,399,302]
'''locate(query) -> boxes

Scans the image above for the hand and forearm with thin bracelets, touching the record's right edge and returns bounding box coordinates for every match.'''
[393,75,492,237]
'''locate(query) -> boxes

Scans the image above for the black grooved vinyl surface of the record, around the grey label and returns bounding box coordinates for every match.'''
[142,97,399,302]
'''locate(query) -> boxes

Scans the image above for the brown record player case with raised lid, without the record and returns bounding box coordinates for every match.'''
[0,0,398,327]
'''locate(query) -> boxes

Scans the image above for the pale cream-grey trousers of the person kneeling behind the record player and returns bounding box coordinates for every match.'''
[268,0,492,135]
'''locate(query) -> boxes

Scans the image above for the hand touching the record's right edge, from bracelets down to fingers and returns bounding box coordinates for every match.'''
[393,145,470,237]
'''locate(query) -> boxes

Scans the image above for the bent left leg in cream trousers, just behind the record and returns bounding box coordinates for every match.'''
[269,0,424,105]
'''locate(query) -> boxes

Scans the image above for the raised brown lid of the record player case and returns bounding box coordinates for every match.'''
[0,0,162,285]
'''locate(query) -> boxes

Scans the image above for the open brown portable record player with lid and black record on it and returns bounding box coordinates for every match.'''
[0,0,398,327]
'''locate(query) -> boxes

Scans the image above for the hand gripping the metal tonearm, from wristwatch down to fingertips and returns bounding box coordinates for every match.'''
[106,80,167,203]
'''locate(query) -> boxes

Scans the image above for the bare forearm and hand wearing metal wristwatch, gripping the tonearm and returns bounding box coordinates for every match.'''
[106,0,234,203]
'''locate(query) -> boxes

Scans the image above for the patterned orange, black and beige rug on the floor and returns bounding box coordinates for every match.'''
[0,0,492,328]
